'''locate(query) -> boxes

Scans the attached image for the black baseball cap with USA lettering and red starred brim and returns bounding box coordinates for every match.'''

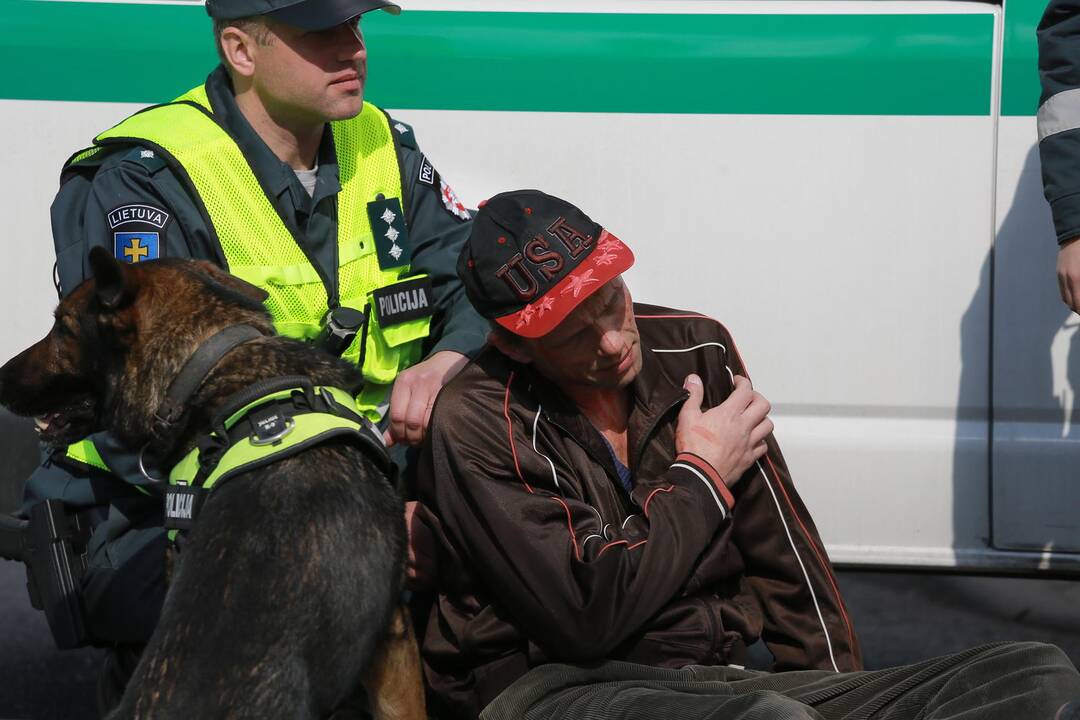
[458,190,634,338]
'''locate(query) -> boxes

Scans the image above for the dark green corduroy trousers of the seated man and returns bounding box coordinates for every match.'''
[481,642,1080,720]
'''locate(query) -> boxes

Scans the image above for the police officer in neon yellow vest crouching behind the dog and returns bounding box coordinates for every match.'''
[25,0,486,705]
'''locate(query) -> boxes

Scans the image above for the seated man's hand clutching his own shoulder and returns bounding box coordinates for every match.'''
[675,375,772,488]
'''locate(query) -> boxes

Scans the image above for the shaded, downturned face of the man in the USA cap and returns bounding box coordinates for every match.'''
[521,275,642,390]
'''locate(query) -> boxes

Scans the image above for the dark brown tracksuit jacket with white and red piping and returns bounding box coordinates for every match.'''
[418,304,862,717]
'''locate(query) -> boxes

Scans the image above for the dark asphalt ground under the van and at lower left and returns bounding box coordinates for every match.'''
[0,561,1080,720]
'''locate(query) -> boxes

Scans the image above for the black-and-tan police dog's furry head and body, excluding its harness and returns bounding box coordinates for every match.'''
[0,248,426,720]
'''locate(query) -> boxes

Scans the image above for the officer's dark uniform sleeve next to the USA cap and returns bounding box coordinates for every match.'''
[391,126,488,357]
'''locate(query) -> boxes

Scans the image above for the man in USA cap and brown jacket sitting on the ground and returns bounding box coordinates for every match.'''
[413,191,1080,720]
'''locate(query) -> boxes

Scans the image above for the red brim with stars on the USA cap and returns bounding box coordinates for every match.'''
[495,230,634,338]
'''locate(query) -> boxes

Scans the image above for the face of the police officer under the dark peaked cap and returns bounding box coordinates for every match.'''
[252,17,367,123]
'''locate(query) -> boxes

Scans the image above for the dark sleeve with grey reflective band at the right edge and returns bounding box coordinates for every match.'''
[1038,0,1080,243]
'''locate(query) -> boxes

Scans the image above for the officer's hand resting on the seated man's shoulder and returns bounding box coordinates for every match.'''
[383,350,469,446]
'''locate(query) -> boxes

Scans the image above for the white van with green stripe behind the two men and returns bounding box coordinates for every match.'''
[0,0,1080,573]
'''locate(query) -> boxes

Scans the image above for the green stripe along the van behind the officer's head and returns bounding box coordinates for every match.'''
[0,0,993,116]
